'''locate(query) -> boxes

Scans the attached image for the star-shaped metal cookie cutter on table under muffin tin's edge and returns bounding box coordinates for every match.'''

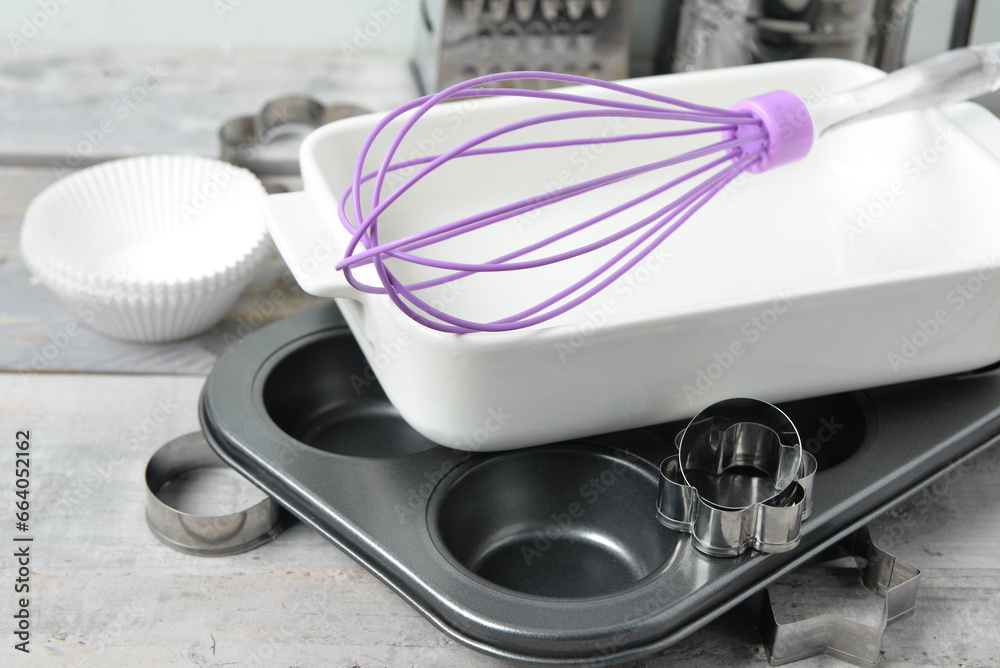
[736,527,920,666]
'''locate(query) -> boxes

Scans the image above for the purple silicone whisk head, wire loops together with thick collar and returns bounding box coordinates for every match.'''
[337,72,813,333]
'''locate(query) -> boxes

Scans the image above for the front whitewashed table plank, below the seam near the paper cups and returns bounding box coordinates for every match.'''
[0,374,1000,668]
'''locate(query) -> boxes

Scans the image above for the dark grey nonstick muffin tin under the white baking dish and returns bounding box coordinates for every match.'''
[201,303,1000,665]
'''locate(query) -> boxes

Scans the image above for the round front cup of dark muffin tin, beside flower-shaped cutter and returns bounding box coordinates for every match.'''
[427,443,686,599]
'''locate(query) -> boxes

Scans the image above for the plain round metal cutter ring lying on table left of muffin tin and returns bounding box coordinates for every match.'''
[146,432,292,557]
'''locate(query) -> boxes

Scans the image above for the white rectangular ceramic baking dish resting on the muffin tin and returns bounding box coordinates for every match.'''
[265,60,1000,450]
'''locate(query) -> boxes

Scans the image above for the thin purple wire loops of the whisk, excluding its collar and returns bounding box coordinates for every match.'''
[337,72,768,333]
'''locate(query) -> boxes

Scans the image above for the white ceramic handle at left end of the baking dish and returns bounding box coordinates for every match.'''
[264,192,361,300]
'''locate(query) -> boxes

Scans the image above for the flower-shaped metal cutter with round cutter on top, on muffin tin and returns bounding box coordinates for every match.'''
[656,399,817,557]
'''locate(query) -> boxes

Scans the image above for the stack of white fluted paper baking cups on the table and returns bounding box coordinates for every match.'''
[21,155,270,341]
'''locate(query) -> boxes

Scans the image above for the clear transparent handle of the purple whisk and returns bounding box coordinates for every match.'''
[811,42,1000,137]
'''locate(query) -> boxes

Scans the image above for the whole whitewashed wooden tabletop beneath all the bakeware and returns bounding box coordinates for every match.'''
[0,52,1000,668]
